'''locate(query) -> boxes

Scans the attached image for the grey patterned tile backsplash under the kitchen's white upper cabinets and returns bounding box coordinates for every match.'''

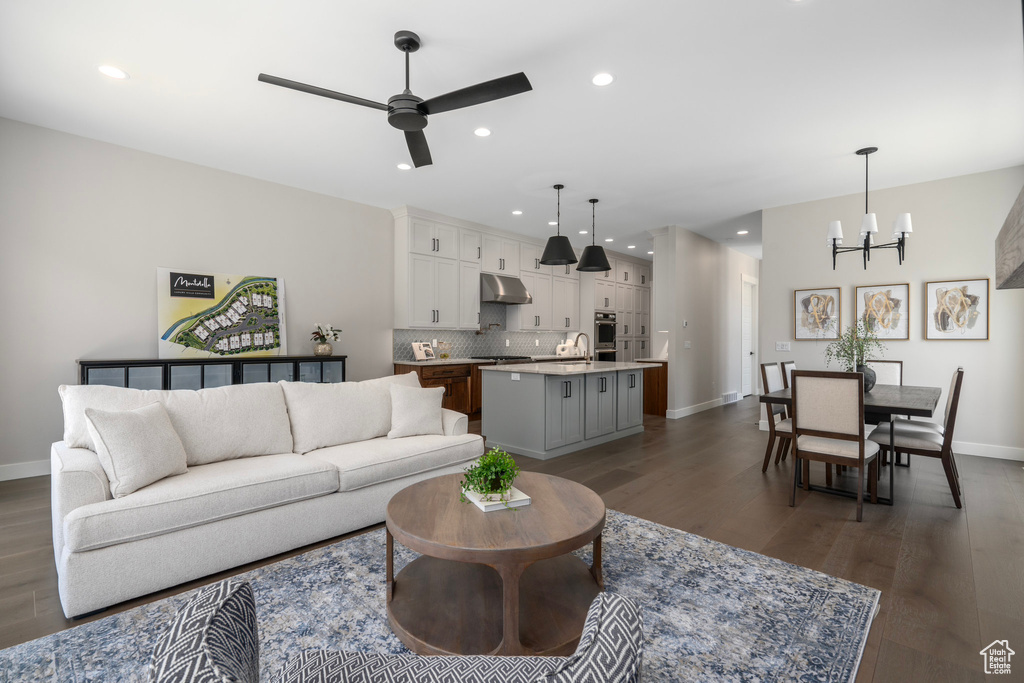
[393,303,585,360]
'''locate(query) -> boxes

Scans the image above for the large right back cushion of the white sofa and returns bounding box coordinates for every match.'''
[281,373,420,453]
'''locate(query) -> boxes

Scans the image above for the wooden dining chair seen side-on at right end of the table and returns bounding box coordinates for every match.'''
[868,368,964,508]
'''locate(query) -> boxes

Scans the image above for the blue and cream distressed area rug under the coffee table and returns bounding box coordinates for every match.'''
[0,510,880,683]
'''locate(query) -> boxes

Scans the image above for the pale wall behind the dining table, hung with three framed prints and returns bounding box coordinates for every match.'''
[760,166,1024,460]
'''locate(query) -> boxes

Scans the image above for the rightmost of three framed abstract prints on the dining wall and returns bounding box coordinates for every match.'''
[925,278,988,340]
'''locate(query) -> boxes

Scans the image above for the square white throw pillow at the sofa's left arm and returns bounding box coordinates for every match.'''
[85,403,187,498]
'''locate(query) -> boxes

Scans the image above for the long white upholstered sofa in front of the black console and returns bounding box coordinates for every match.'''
[50,373,483,616]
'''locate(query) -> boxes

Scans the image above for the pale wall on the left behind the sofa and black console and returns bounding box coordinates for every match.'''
[0,119,394,479]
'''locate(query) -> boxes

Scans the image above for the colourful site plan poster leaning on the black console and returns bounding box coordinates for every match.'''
[157,268,288,358]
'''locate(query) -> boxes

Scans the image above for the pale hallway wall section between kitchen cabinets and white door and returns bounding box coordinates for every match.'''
[652,226,759,418]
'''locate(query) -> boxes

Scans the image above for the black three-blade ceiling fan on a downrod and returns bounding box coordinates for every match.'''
[259,31,534,168]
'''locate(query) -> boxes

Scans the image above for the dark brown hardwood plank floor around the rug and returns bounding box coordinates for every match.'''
[0,397,1024,682]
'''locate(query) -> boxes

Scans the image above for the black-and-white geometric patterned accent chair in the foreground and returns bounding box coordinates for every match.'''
[150,580,643,683]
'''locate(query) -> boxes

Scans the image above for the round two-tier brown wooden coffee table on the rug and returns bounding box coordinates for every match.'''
[387,472,604,655]
